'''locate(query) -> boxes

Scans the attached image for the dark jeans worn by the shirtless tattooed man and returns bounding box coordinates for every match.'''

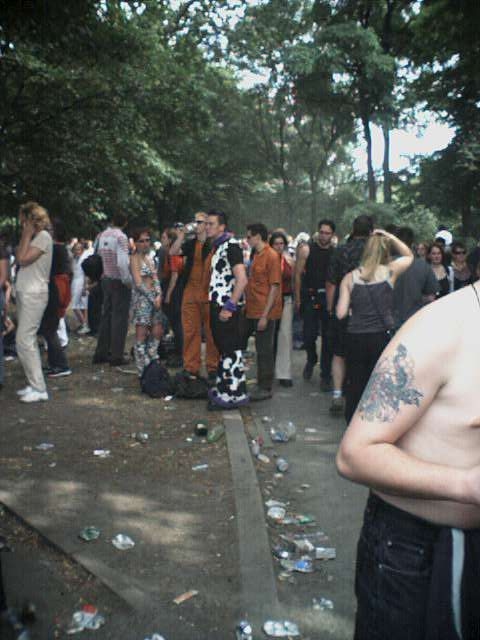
[354,494,480,640]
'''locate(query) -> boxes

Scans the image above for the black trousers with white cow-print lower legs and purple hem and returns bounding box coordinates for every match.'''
[209,303,248,408]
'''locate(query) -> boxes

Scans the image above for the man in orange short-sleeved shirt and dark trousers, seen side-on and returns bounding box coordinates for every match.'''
[245,223,282,400]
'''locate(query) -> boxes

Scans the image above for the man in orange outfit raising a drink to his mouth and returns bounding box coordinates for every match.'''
[170,211,218,383]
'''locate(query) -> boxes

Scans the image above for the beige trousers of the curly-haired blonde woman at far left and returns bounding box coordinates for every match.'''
[16,291,48,392]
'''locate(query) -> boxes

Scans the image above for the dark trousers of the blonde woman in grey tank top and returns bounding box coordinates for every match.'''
[345,331,389,422]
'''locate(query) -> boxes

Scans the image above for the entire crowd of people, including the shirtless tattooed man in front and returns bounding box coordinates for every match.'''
[0,202,480,640]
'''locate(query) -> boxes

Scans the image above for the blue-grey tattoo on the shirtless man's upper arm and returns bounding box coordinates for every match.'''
[358,344,423,422]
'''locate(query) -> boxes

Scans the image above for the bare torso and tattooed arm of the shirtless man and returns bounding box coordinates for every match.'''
[337,283,480,528]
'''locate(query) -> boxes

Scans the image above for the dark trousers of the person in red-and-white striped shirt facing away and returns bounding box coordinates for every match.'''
[95,278,132,361]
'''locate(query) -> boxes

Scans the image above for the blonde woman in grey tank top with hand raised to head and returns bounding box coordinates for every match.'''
[337,229,413,422]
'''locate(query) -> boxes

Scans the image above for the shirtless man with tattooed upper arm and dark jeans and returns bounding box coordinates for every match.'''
[337,282,480,640]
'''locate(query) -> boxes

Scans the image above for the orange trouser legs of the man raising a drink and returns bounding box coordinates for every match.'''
[182,298,219,375]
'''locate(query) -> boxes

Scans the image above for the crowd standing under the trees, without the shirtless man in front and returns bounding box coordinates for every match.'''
[0,202,480,421]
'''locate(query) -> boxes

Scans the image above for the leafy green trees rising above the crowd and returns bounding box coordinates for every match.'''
[0,0,480,236]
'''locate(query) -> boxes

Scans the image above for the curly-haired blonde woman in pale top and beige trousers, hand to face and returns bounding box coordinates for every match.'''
[16,202,53,402]
